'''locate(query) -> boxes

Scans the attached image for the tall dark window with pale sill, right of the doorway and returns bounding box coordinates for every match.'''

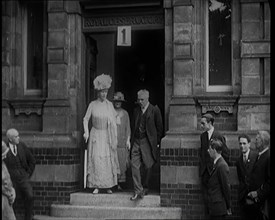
[206,0,232,92]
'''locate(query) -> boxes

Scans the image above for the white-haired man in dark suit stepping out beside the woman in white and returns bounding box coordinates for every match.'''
[131,90,163,201]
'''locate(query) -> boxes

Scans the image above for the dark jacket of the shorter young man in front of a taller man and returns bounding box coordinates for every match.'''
[208,157,231,216]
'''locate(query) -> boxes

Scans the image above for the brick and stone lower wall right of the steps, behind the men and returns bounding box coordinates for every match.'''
[160,134,246,220]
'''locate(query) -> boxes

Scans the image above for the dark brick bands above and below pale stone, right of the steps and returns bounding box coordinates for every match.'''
[160,148,245,219]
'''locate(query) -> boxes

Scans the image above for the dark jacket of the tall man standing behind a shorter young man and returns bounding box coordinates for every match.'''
[199,129,229,176]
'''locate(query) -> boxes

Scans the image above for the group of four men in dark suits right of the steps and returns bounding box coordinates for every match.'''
[199,114,270,220]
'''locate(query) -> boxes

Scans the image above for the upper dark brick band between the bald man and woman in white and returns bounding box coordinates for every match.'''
[31,148,80,165]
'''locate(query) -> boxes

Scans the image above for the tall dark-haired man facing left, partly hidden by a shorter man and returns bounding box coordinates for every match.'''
[199,113,229,214]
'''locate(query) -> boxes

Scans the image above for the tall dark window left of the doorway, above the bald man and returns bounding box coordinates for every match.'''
[23,1,46,95]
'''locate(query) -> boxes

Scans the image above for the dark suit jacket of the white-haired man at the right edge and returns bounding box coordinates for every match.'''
[249,150,270,203]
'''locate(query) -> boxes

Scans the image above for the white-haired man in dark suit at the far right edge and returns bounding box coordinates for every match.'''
[248,131,270,220]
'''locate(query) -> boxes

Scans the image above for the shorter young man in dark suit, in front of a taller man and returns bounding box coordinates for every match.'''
[208,139,232,220]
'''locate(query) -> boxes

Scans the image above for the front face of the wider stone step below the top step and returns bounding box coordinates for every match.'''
[51,206,181,219]
